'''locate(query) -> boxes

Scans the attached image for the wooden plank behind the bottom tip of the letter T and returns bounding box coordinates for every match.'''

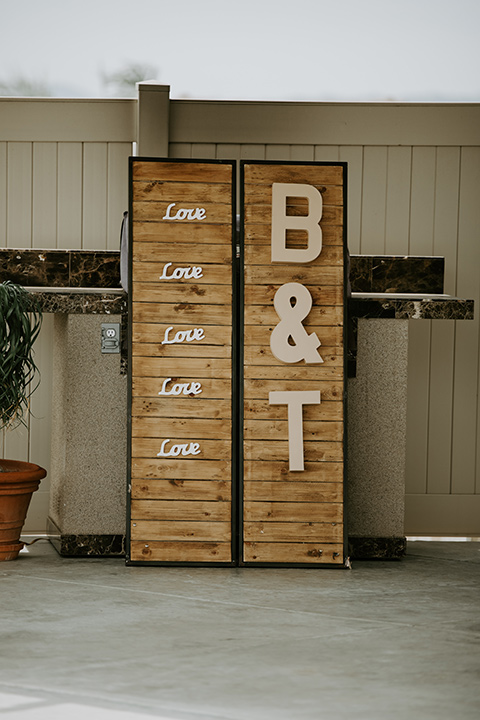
[244,460,343,483]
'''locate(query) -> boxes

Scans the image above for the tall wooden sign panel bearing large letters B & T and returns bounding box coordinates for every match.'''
[241,161,346,566]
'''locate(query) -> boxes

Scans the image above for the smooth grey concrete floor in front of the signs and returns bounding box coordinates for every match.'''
[0,541,480,720]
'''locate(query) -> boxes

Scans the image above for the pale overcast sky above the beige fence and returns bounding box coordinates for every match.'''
[0,0,480,101]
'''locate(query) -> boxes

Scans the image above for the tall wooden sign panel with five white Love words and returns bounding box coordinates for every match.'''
[127,158,234,564]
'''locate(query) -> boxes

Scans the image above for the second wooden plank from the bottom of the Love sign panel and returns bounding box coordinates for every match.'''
[131,520,231,542]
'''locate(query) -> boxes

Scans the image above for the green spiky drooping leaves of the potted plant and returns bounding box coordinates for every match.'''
[0,280,42,428]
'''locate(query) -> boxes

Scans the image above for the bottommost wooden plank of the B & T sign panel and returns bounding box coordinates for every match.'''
[243,542,343,565]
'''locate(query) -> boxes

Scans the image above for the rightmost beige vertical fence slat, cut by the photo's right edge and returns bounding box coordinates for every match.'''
[452,148,480,493]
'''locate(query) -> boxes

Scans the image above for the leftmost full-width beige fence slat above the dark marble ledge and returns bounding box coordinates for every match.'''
[7,142,32,248]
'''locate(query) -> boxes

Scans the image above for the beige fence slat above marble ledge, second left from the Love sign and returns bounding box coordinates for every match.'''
[82,143,108,250]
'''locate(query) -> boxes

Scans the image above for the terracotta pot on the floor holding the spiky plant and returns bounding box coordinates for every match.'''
[0,460,47,561]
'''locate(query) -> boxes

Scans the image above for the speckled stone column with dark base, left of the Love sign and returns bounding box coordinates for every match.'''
[48,314,127,555]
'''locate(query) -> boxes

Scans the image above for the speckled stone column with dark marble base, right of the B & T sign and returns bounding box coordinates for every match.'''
[347,318,408,558]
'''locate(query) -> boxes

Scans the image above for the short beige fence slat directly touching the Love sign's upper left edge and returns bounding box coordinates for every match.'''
[107,143,132,250]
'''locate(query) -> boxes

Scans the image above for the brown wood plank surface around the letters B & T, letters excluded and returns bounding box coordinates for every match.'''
[243,164,344,564]
